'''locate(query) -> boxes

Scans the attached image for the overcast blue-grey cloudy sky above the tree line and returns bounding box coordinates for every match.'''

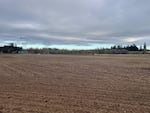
[0,0,150,47]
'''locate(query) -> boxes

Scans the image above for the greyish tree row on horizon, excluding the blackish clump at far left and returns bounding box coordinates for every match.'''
[24,43,146,55]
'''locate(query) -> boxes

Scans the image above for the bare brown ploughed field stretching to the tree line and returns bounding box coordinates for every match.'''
[0,55,150,113]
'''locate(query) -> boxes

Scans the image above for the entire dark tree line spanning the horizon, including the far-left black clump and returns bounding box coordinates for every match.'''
[0,43,148,55]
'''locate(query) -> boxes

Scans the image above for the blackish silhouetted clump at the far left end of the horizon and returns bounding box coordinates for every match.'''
[0,43,22,53]
